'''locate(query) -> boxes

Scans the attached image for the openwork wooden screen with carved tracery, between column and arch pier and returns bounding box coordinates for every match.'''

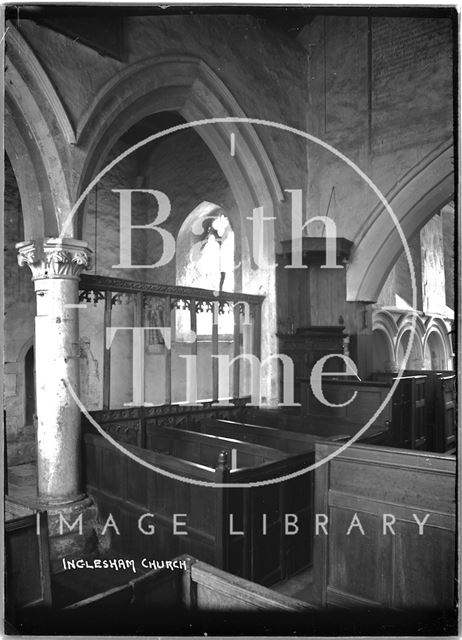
[79,275,264,410]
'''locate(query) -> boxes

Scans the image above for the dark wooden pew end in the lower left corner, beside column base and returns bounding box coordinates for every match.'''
[5,497,51,632]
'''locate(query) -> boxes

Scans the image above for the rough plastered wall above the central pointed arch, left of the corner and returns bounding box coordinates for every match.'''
[18,14,306,215]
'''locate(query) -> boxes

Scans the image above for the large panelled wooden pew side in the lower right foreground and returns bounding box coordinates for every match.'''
[314,442,456,612]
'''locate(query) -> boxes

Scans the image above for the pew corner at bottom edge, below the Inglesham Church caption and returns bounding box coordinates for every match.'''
[20,555,315,637]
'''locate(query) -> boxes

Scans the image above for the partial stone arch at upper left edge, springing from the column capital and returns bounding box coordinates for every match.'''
[5,23,75,240]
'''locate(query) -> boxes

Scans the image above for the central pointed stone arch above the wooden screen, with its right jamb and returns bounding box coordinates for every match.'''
[77,56,283,402]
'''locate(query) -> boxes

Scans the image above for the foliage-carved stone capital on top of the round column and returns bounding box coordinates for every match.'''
[16,238,91,280]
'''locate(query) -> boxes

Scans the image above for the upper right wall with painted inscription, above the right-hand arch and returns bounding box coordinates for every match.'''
[299,15,453,330]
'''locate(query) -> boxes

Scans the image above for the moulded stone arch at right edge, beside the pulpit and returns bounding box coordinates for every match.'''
[347,142,454,301]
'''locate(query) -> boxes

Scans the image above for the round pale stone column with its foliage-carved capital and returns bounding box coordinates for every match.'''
[16,238,90,510]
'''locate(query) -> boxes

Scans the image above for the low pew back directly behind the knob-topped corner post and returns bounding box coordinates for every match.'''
[146,426,284,467]
